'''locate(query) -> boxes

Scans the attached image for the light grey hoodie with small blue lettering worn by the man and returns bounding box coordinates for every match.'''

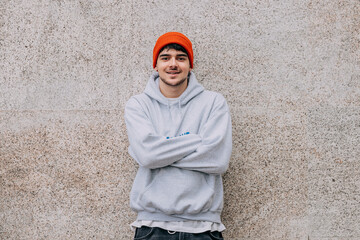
[125,72,232,223]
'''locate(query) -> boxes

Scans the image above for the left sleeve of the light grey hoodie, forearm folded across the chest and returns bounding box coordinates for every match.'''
[125,97,201,169]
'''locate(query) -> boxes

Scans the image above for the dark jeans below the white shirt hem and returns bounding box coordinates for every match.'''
[134,226,224,240]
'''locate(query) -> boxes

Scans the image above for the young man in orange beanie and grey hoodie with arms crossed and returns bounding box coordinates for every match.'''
[125,32,232,240]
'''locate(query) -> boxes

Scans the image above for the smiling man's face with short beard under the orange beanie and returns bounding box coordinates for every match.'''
[155,49,191,87]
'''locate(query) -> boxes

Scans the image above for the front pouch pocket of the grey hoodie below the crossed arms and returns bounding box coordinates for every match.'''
[139,167,214,215]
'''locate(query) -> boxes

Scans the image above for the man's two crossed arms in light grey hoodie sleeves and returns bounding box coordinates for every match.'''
[125,95,232,174]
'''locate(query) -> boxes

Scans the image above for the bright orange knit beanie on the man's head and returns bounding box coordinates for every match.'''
[153,32,194,68]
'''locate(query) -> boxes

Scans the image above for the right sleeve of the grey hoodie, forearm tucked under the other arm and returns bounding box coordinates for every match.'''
[172,95,232,174]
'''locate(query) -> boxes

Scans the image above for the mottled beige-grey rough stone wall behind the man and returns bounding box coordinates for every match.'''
[0,0,360,240]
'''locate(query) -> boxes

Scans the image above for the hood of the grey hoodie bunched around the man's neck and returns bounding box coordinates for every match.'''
[144,72,204,105]
